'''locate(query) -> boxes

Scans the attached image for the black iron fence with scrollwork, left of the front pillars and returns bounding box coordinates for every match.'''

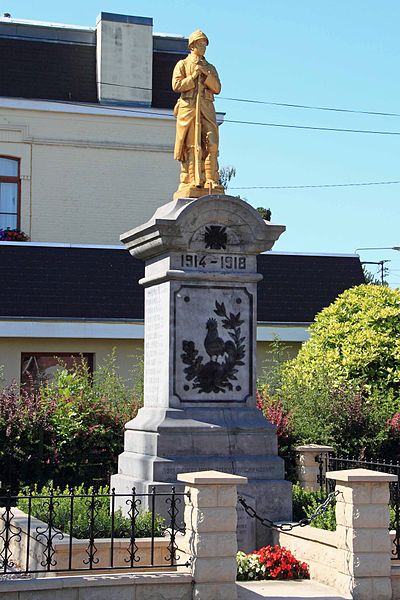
[0,487,190,575]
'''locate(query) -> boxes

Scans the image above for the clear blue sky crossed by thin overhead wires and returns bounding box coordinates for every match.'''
[6,0,400,287]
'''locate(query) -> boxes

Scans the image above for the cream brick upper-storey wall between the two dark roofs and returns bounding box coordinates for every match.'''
[0,108,179,244]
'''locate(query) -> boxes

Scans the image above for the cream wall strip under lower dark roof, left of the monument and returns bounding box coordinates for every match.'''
[0,338,143,383]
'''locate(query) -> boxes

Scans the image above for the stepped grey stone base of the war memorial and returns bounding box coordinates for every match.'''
[111,407,292,552]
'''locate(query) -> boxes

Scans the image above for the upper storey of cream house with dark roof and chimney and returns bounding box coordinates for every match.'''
[0,13,191,244]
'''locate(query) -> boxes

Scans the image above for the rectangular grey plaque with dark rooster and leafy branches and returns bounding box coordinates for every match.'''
[174,285,253,402]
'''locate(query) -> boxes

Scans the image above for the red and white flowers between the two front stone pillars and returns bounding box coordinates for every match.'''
[236,546,310,581]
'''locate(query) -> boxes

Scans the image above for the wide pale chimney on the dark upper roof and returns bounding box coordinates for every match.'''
[96,12,153,106]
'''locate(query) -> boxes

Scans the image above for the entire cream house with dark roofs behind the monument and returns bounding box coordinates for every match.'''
[0,13,364,382]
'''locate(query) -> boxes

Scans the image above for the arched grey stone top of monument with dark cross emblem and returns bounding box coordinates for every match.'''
[121,195,285,259]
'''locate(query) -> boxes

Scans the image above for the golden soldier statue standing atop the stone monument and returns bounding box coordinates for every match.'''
[172,30,224,198]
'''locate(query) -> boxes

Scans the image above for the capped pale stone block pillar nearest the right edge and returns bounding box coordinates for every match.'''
[326,469,397,600]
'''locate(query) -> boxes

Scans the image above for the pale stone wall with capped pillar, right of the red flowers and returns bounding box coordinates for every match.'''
[275,469,400,600]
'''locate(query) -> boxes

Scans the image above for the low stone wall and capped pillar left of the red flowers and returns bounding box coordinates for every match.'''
[0,471,247,600]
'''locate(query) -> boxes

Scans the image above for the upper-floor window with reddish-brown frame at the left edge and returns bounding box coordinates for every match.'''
[0,156,20,229]
